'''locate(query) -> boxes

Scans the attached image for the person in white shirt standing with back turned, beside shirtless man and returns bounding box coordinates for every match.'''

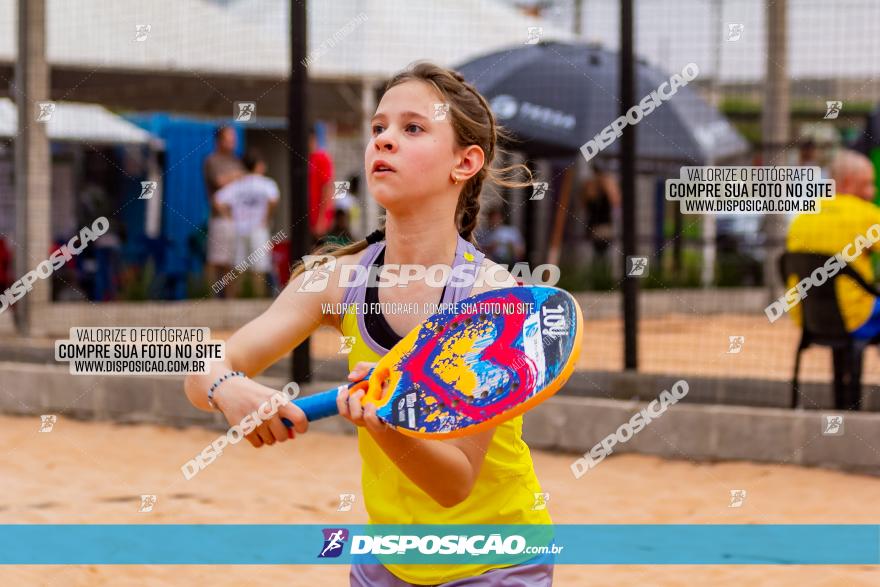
[214,151,279,297]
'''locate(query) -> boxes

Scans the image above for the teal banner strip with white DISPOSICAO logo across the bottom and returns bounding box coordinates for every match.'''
[0,524,880,565]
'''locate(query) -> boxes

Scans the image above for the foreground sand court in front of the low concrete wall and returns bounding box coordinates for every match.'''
[0,417,880,587]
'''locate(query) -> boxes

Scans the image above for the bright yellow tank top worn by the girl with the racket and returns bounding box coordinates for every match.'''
[341,238,552,585]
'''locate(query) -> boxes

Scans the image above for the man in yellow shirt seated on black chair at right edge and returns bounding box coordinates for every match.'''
[786,150,880,340]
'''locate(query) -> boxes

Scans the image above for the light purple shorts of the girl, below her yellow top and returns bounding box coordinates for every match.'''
[349,564,553,587]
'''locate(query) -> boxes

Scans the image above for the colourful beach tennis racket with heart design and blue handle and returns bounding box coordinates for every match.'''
[282,286,583,439]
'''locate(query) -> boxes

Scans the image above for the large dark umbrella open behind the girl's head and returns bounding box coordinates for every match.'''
[457,42,748,165]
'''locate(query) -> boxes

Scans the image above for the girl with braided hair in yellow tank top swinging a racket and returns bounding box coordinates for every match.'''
[186,63,553,587]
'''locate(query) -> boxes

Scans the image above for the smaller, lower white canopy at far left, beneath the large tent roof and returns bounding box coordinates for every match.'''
[0,98,160,145]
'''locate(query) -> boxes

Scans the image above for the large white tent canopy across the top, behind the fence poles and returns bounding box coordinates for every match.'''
[0,0,573,79]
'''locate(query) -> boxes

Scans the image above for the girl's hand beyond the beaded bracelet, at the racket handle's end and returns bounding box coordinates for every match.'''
[214,377,309,448]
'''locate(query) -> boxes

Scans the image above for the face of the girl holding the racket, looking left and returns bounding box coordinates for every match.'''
[364,81,461,211]
